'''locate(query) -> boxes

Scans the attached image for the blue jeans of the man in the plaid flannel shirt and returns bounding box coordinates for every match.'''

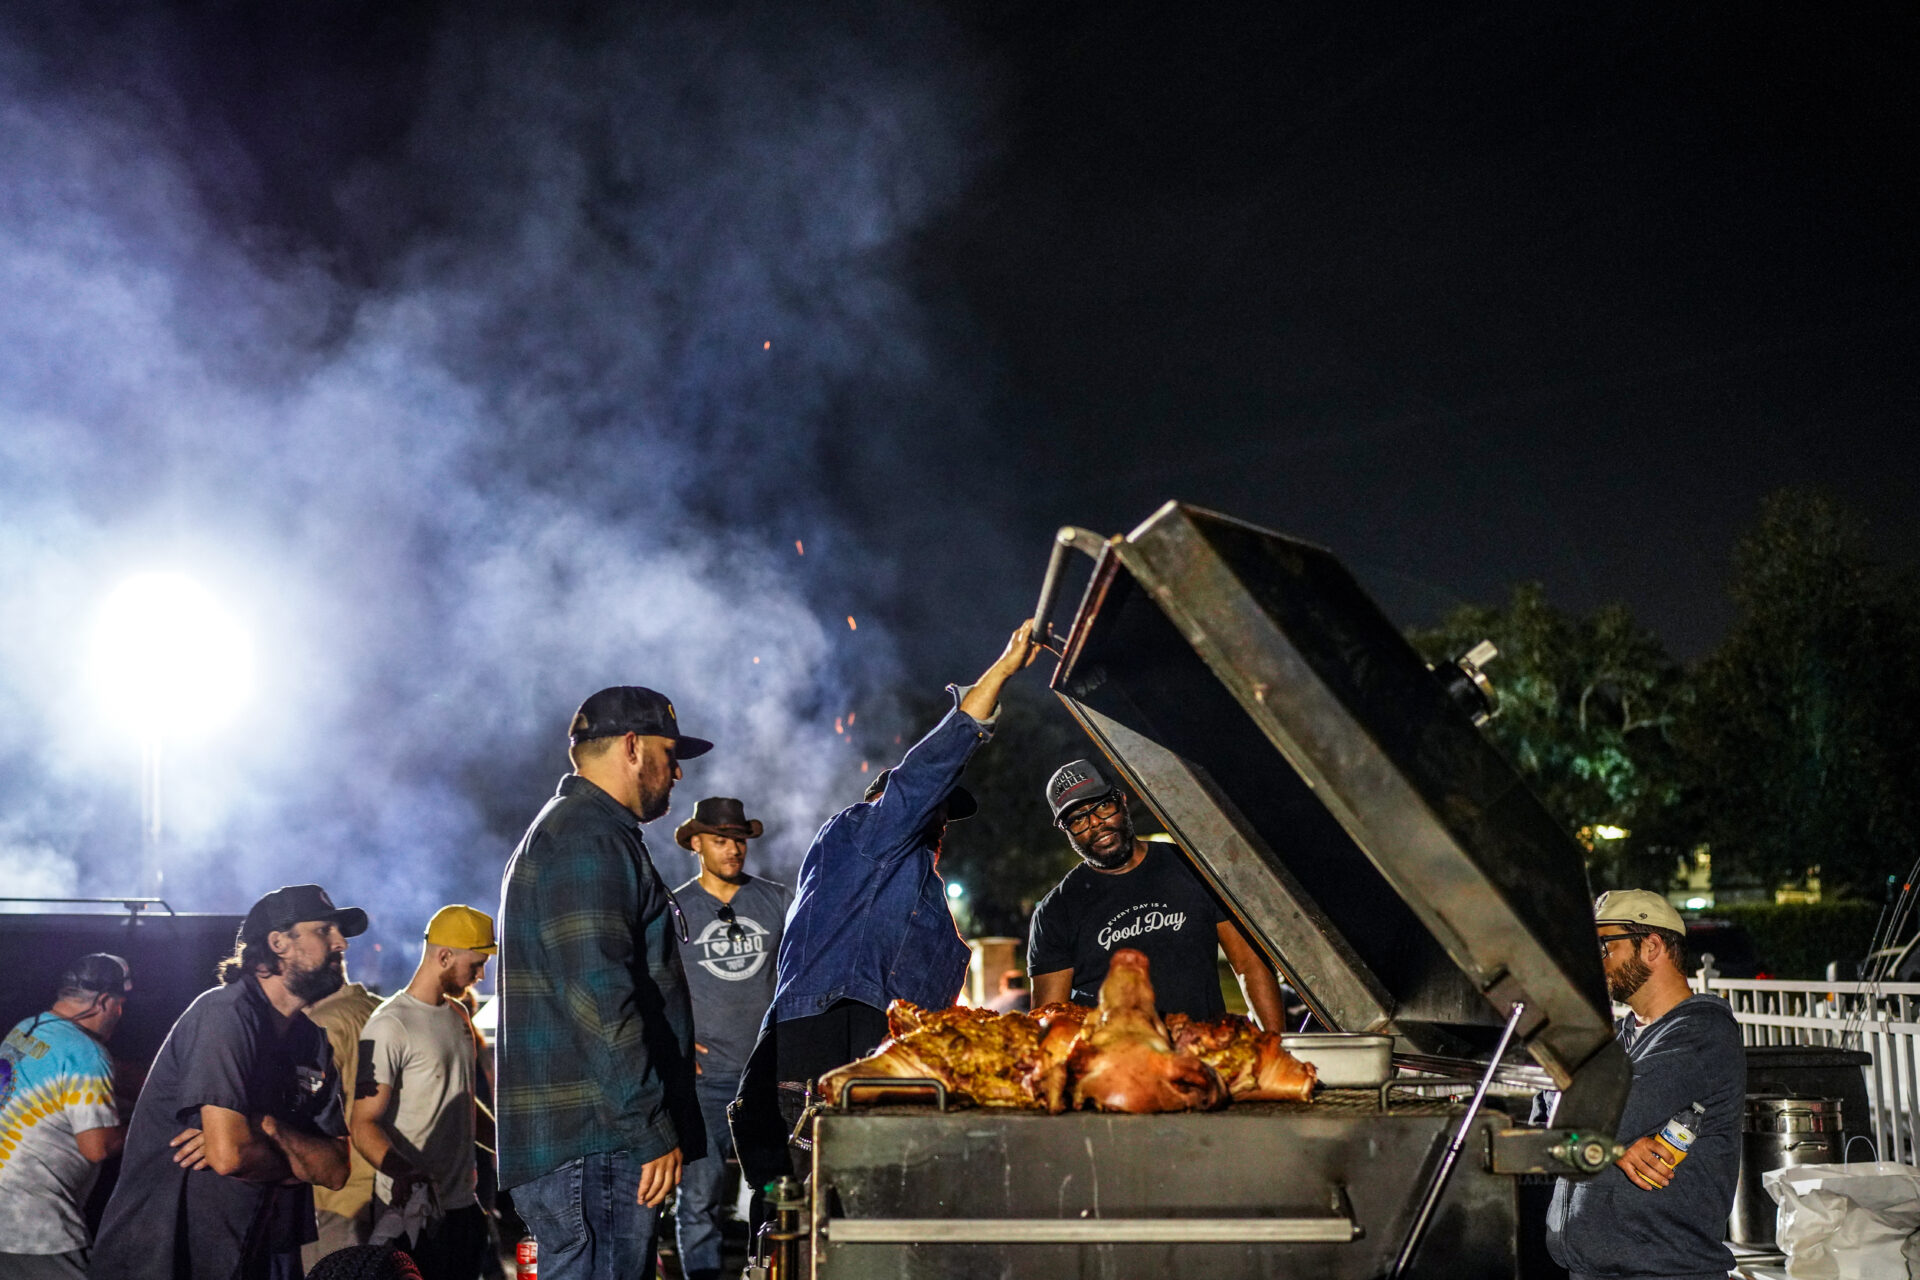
[513,1151,660,1280]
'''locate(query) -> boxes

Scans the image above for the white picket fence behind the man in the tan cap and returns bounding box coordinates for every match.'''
[1693,977,1920,1165]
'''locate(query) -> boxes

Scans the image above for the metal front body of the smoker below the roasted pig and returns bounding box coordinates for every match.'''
[812,1105,1517,1280]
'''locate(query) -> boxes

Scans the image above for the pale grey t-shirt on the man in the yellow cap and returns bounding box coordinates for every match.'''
[355,990,476,1213]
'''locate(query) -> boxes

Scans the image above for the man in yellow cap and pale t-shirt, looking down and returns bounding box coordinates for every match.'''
[353,906,499,1280]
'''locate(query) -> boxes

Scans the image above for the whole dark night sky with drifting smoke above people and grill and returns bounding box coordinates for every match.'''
[0,2,1920,921]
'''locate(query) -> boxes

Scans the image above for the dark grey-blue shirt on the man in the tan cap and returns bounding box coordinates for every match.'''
[1548,996,1747,1280]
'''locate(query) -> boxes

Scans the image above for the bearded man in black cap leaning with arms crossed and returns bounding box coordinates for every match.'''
[88,885,367,1280]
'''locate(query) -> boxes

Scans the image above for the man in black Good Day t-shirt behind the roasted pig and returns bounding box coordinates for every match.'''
[1027,760,1284,1031]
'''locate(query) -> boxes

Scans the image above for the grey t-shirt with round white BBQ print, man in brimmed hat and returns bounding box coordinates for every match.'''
[674,877,793,1084]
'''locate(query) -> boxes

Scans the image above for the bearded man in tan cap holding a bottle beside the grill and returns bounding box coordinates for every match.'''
[1548,889,1747,1280]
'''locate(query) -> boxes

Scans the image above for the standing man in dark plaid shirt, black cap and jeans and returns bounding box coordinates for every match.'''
[495,685,712,1280]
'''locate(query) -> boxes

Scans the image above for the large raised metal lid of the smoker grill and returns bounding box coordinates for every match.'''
[1043,503,1628,1130]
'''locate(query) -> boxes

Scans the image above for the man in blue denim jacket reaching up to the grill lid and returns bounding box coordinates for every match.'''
[735,622,1037,1182]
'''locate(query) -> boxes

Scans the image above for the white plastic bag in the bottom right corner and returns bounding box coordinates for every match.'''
[1761,1161,1920,1280]
